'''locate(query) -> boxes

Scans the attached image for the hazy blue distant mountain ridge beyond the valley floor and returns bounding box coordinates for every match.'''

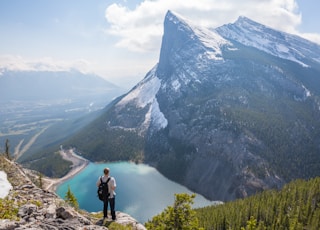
[0,71,120,103]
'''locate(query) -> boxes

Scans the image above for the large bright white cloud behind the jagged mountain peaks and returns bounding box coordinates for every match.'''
[105,0,320,51]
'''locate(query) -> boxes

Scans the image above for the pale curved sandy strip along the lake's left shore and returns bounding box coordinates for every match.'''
[43,149,89,192]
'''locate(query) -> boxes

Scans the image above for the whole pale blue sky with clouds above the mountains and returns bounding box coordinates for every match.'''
[0,0,320,89]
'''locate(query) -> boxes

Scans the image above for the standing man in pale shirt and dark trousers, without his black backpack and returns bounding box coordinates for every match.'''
[97,168,117,221]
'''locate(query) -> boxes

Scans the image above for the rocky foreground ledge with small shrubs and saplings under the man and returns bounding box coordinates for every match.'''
[0,154,145,230]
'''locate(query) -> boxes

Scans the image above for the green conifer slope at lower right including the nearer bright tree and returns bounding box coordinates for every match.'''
[146,177,320,230]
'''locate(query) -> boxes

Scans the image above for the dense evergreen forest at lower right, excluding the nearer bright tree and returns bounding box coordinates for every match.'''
[195,177,320,230]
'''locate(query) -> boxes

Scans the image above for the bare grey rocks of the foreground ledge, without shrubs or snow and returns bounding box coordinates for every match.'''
[0,158,145,230]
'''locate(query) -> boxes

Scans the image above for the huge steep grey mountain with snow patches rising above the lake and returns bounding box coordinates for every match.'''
[69,11,320,200]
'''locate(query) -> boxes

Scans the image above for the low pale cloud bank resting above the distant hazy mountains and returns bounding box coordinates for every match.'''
[0,55,157,89]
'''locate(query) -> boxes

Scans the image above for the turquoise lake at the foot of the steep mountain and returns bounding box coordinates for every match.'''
[56,162,214,223]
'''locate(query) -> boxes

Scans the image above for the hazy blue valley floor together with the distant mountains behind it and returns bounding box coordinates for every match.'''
[0,70,125,164]
